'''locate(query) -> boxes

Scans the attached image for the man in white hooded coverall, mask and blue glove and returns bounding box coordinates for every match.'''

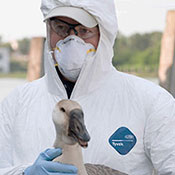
[0,0,175,175]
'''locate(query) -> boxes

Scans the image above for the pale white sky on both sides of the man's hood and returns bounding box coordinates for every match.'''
[0,0,175,41]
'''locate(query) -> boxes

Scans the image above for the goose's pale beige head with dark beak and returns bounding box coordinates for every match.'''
[52,100,90,148]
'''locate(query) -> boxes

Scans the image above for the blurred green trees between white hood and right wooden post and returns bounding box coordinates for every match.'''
[113,32,162,76]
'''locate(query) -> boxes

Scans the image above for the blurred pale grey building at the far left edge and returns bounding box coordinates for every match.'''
[0,48,10,73]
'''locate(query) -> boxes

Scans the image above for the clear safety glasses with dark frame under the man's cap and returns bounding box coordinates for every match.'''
[49,18,98,39]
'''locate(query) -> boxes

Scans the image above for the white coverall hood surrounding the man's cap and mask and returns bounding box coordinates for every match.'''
[41,0,117,98]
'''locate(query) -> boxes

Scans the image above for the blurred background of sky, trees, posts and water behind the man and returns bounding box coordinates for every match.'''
[0,0,175,101]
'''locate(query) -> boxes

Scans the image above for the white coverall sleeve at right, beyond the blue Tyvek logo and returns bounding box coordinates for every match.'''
[144,91,175,175]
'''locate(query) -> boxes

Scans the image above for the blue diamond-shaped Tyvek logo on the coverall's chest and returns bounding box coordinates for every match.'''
[109,127,137,155]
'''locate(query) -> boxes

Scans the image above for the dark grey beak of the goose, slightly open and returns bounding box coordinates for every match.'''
[68,109,90,148]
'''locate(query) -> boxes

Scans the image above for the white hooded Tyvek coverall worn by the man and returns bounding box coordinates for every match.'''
[0,0,175,175]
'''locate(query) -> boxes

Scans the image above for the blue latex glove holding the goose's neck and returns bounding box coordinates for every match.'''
[24,148,77,175]
